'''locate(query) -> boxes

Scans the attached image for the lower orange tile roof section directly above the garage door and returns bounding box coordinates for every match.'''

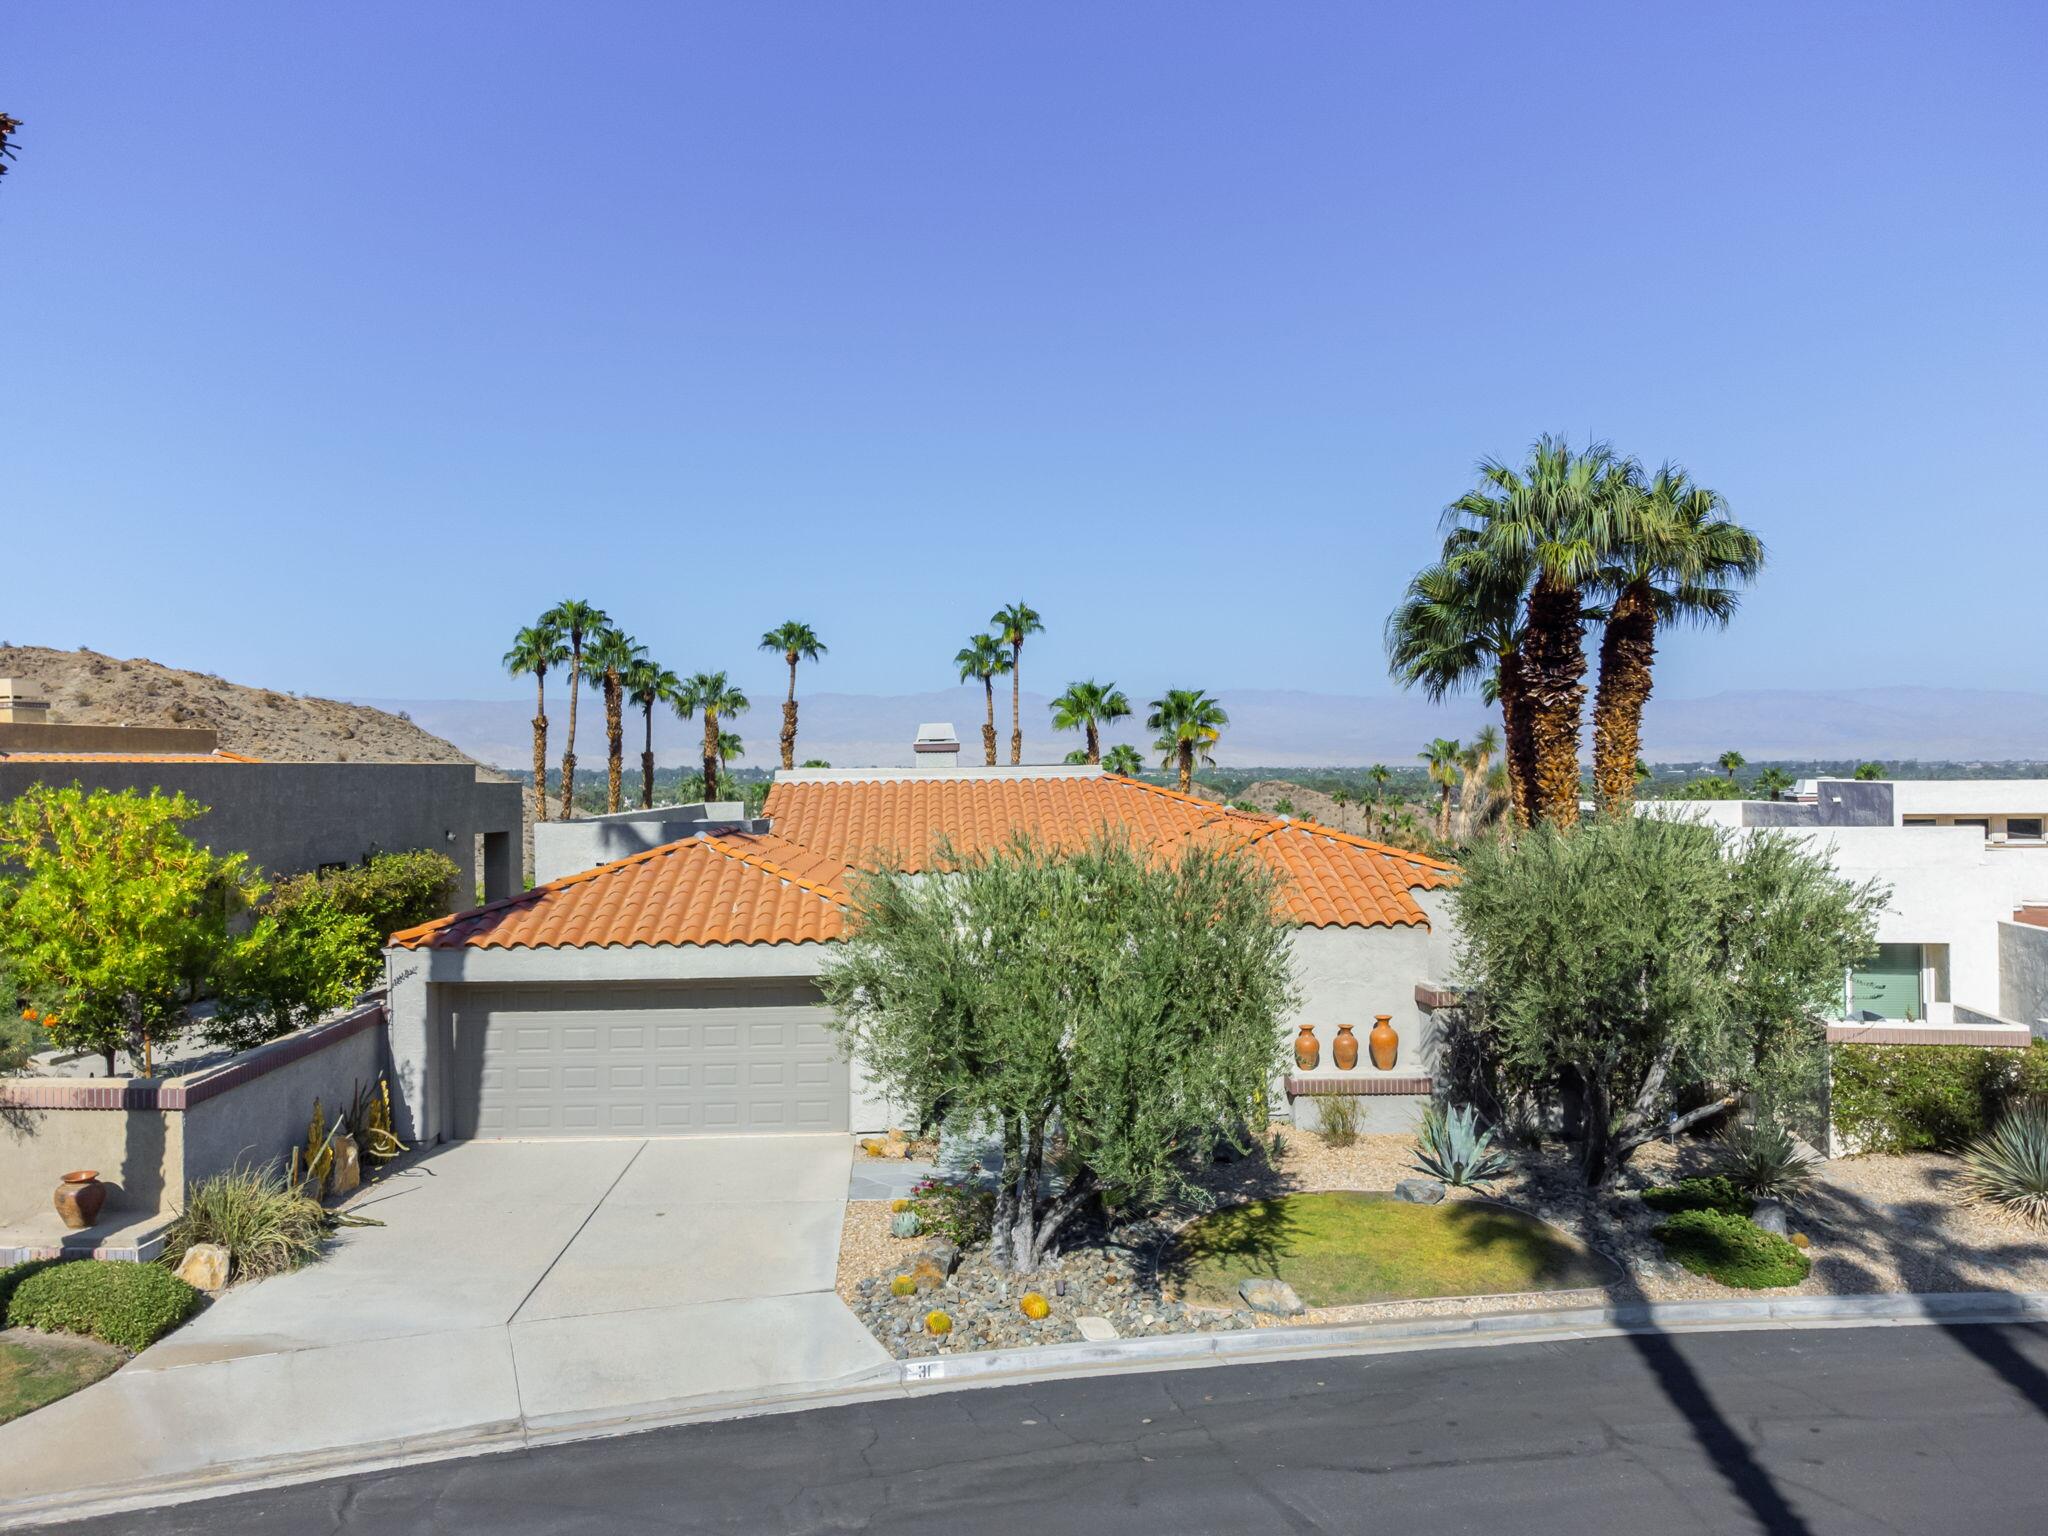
[391,834,846,950]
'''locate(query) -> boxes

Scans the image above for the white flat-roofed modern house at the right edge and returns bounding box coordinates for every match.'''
[1638,778,2048,1044]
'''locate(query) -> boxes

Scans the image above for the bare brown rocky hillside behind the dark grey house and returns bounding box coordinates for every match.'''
[0,645,483,778]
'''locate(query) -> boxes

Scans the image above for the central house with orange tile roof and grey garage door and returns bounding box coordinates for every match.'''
[387,733,1456,1141]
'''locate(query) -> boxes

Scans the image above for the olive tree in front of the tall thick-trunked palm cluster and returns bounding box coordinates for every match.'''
[1452,815,1884,1186]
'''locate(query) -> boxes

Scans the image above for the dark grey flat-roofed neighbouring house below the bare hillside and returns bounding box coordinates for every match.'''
[0,678,522,901]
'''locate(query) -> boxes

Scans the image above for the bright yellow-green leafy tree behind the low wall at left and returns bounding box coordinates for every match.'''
[0,784,262,1073]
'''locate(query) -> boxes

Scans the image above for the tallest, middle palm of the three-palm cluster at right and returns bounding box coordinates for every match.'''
[1444,436,1620,827]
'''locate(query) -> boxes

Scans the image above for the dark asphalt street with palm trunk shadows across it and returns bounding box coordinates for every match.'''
[36,1325,2048,1536]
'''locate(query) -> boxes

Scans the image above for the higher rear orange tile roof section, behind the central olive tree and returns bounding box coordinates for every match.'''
[764,774,1458,928]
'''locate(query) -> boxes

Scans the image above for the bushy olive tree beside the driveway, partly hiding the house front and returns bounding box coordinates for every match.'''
[823,840,1292,1270]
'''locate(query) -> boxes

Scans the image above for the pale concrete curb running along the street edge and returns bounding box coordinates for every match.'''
[0,1290,2048,1530]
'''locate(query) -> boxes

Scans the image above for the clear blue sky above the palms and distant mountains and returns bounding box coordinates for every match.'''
[0,0,2048,712]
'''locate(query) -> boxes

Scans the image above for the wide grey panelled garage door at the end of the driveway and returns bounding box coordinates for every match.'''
[451,983,850,1139]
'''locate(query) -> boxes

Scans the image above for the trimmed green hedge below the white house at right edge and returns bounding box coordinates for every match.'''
[1829,1040,2048,1153]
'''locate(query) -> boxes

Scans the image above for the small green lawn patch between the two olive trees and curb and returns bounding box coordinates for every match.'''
[1169,1192,1618,1307]
